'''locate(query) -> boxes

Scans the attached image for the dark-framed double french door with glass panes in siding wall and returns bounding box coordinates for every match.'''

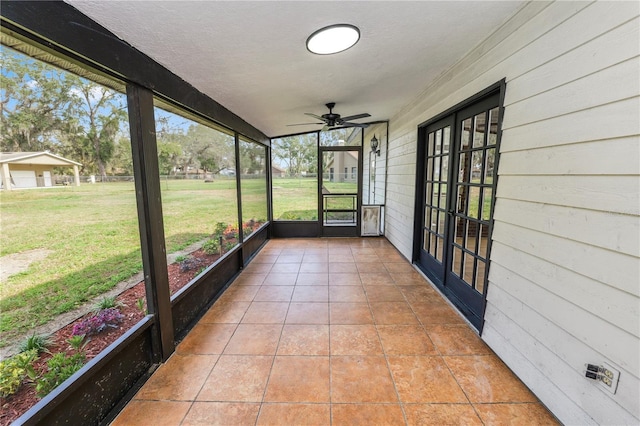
[414,86,503,330]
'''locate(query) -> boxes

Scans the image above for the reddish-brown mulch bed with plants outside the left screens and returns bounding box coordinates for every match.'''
[0,245,230,426]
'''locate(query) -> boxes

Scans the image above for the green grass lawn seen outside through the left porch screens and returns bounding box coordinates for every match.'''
[0,179,248,346]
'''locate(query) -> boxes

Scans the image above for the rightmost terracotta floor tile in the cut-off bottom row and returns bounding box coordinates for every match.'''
[475,403,560,426]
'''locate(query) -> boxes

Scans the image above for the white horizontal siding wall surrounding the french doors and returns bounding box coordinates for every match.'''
[386,2,640,424]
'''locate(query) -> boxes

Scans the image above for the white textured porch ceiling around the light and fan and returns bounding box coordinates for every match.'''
[66,0,525,136]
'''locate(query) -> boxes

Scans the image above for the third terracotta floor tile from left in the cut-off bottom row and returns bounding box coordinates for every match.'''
[256,403,331,426]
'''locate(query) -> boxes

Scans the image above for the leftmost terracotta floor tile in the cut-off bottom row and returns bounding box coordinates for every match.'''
[111,400,191,426]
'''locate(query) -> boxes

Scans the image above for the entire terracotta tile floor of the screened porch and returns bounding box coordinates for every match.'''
[113,238,556,425]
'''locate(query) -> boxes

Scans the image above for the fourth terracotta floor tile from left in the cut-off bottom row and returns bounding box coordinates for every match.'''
[331,404,405,426]
